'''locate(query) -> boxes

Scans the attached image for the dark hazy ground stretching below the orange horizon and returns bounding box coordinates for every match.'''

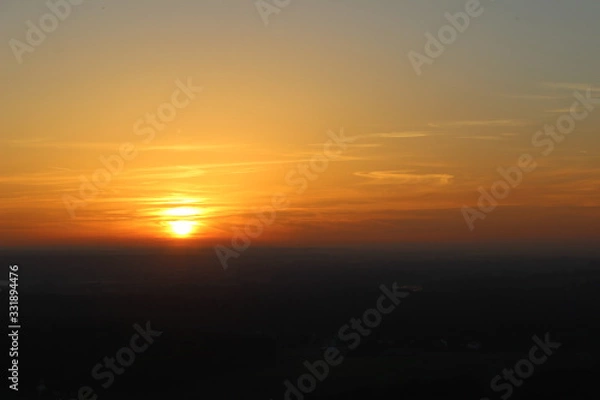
[0,245,600,399]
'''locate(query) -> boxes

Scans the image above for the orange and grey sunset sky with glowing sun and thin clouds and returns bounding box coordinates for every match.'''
[0,0,600,247]
